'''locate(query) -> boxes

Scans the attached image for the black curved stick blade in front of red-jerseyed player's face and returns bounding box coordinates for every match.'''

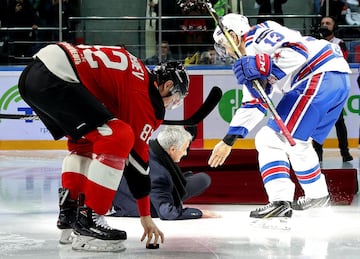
[163,86,222,126]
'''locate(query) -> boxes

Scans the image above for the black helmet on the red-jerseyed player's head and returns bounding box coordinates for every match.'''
[153,61,190,99]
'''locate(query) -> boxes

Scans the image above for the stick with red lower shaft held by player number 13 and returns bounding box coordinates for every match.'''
[204,2,296,146]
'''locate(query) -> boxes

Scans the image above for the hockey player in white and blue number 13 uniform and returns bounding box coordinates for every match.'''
[208,13,351,218]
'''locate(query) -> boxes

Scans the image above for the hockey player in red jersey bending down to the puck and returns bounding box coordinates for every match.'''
[19,42,189,251]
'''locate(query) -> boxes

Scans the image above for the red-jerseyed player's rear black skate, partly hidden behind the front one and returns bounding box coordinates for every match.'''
[56,188,77,245]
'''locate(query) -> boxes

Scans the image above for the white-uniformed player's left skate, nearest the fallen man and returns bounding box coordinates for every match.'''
[250,201,292,230]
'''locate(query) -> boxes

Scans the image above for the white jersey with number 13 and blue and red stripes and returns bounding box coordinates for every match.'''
[227,21,351,141]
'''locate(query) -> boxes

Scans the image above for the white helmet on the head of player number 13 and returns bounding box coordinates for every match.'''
[213,13,250,45]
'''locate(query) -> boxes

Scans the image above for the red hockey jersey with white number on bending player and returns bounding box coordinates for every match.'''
[58,42,162,163]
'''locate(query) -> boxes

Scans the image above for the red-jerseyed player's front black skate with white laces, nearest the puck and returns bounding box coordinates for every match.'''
[72,195,127,252]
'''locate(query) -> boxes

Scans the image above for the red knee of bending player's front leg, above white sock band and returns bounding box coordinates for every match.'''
[85,119,135,158]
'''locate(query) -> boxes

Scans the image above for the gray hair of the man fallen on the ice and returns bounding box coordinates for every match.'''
[157,126,192,151]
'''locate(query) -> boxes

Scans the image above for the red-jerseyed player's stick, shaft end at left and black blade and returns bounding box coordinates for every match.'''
[0,86,222,126]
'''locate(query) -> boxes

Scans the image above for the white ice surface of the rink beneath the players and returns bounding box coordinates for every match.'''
[0,149,360,259]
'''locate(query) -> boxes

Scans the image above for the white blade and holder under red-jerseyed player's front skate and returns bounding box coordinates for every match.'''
[71,235,126,252]
